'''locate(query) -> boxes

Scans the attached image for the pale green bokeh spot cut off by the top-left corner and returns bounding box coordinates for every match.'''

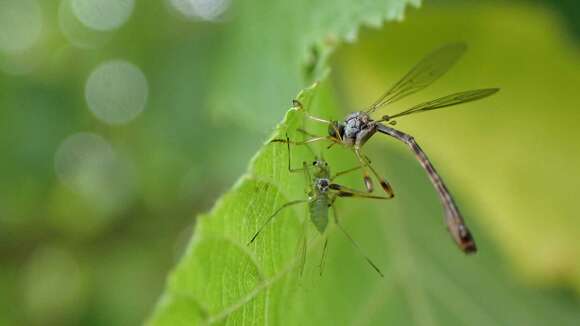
[0,0,42,52]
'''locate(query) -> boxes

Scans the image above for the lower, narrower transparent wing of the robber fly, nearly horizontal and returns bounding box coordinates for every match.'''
[385,88,499,120]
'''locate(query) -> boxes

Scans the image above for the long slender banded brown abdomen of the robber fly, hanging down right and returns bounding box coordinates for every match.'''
[378,124,477,253]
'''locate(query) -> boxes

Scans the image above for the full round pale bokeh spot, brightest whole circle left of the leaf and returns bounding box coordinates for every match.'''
[85,60,149,125]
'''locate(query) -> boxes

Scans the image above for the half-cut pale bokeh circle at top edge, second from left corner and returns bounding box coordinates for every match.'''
[72,0,135,31]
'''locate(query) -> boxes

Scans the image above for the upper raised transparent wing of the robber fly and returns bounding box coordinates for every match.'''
[367,43,467,113]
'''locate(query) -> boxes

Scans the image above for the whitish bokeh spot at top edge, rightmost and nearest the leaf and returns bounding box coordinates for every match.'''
[169,0,230,21]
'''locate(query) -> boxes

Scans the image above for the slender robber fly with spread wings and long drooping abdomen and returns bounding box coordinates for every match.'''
[294,43,499,253]
